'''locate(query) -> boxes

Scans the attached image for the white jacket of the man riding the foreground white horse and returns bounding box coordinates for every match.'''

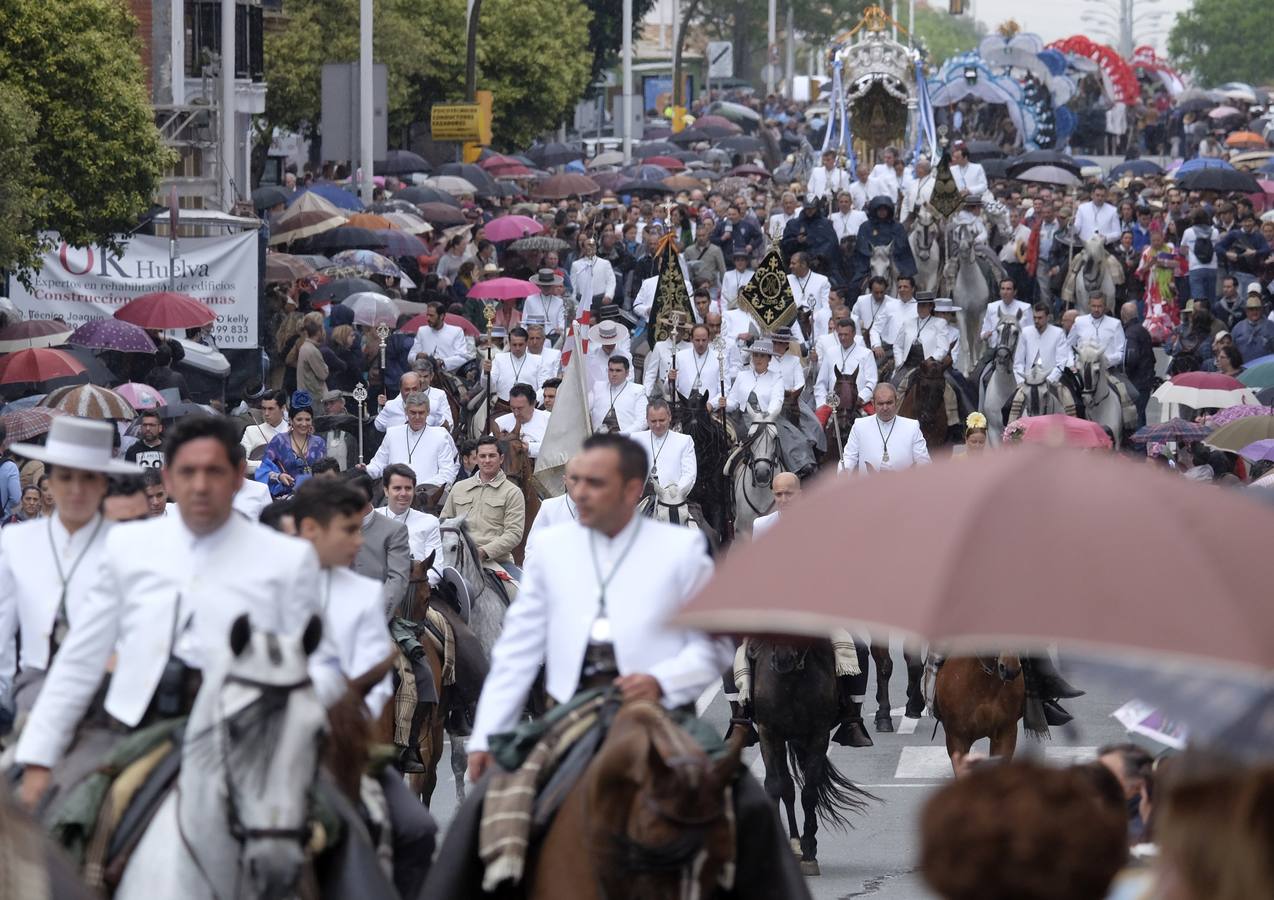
[17,514,349,767]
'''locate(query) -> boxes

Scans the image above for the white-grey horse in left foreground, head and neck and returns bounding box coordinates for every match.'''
[115,616,327,900]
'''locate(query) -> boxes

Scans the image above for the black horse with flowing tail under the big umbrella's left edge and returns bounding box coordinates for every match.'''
[749,640,879,875]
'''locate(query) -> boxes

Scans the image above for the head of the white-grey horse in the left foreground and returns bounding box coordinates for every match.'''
[208,614,327,897]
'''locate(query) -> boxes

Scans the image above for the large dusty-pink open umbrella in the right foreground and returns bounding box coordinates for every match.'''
[673,447,1274,677]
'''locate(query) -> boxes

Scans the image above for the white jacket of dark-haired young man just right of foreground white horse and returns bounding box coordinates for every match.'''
[319,569,394,719]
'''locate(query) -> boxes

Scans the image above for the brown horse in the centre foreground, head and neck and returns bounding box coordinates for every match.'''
[526,701,743,900]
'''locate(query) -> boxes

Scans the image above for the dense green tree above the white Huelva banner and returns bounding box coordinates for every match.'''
[0,0,173,270]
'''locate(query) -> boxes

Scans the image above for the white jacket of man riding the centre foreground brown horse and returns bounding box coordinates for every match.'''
[469,515,733,752]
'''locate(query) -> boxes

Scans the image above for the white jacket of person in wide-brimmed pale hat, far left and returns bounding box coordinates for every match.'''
[0,512,113,678]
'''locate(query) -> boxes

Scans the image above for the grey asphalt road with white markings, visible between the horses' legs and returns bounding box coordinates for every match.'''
[420,634,1130,900]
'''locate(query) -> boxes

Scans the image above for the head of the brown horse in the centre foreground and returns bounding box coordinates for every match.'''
[590,701,743,896]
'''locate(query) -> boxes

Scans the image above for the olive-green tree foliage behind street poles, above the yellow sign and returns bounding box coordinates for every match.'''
[260,0,596,154]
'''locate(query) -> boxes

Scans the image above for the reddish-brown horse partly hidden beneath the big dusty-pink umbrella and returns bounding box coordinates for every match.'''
[934,653,1027,769]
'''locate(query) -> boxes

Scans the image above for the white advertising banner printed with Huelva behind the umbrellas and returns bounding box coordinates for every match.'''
[9,231,260,349]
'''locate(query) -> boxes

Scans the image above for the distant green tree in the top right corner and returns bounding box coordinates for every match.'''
[1168,0,1274,84]
